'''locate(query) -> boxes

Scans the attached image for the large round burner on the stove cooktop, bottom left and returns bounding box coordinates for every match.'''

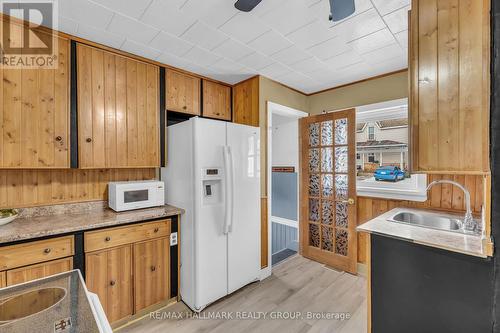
[0,288,66,325]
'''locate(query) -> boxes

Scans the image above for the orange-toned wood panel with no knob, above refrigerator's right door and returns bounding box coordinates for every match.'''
[233,76,259,127]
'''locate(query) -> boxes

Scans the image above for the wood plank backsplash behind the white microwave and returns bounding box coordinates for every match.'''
[0,169,156,208]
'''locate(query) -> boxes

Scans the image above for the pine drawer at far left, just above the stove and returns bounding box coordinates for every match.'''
[0,236,75,270]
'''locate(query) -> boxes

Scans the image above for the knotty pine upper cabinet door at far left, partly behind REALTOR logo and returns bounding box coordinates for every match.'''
[0,31,70,169]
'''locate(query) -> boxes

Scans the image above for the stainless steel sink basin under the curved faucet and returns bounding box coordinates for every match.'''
[388,211,472,233]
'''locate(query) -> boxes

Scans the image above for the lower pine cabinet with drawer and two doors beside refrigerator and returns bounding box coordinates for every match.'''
[84,219,171,323]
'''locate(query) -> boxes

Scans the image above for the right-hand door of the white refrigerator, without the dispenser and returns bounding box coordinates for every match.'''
[227,123,260,293]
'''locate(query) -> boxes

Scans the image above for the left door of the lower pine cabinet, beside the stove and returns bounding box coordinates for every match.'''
[85,245,133,322]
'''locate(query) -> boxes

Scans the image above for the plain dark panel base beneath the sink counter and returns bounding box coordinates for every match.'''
[371,235,493,333]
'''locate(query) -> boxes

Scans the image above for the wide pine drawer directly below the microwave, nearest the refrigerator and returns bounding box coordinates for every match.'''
[84,219,170,252]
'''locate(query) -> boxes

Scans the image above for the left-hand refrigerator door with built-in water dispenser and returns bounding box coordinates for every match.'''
[193,118,227,310]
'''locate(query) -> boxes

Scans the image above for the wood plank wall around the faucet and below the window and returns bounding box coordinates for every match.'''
[357,174,487,263]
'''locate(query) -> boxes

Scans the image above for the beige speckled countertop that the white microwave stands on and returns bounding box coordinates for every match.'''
[0,202,184,244]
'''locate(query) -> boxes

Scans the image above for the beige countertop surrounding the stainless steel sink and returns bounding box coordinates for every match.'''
[356,208,487,258]
